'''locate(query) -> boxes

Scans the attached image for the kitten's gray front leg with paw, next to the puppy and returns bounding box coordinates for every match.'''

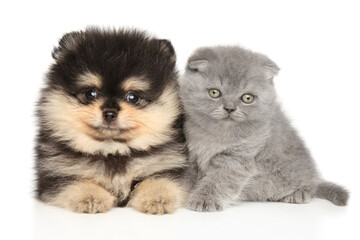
[187,155,254,212]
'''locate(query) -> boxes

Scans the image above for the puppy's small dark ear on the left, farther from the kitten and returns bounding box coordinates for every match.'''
[51,31,85,60]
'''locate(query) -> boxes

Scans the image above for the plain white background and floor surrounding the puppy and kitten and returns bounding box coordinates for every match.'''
[0,0,360,240]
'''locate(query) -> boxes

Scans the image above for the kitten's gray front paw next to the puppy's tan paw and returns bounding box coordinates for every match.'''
[187,195,224,212]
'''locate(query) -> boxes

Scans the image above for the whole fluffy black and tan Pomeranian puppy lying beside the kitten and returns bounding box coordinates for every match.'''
[36,28,188,214]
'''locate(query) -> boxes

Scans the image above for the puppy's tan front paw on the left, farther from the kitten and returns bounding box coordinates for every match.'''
[45,180,115,213]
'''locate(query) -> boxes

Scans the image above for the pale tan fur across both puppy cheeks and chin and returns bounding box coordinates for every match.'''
[40,83,180,155]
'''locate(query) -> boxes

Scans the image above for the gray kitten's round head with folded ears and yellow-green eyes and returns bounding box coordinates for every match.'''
[180,47,279,125]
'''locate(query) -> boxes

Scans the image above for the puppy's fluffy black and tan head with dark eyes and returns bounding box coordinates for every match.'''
[39,28,180,154]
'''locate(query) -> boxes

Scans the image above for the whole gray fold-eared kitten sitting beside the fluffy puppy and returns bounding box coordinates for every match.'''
[180,47,348,211]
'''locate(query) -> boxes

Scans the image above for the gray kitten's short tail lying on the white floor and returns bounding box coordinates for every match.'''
[315,182,349,206]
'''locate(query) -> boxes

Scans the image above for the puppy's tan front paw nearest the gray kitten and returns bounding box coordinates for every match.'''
[128,178,186,215]
